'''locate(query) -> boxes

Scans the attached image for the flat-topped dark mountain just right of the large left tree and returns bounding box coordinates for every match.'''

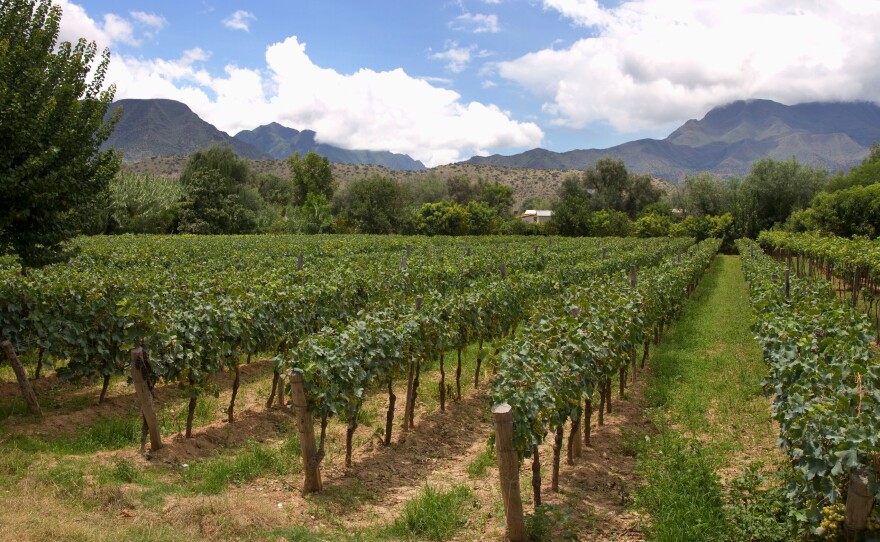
[102,99,268,163]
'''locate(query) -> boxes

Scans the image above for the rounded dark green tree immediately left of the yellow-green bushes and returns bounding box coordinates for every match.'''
[339,175,407,233]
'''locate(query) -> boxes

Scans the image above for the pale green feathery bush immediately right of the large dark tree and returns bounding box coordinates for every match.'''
[109,171,183,233]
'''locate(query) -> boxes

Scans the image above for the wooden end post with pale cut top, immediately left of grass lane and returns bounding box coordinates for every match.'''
[492,403,526,542]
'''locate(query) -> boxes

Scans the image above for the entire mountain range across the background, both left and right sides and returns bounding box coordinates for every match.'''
[105,99,880,182]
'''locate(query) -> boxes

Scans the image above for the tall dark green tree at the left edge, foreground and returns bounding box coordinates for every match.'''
[0,0,119,267]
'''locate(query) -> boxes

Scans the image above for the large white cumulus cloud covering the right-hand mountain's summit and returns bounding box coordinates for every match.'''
[497,0,880,132]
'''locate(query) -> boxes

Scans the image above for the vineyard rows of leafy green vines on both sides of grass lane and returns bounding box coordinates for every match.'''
[0,235,880,540]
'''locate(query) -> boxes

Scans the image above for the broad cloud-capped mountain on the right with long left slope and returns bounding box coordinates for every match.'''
[465,100,880,182]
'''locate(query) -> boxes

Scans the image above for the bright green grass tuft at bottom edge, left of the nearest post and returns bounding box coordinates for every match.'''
[387,485,473,540]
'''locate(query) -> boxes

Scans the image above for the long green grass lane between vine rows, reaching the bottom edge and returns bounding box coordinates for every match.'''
[625,256,775,541]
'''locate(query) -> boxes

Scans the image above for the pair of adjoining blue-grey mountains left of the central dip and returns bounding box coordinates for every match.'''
[103,99,425,170]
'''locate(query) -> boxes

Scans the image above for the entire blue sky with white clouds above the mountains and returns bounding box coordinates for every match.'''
[53,0,880,166]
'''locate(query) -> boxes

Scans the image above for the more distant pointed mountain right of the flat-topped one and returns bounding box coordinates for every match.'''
[235,122,425,171]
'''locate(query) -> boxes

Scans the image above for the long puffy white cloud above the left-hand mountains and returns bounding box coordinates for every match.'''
[107,37,544,166]
